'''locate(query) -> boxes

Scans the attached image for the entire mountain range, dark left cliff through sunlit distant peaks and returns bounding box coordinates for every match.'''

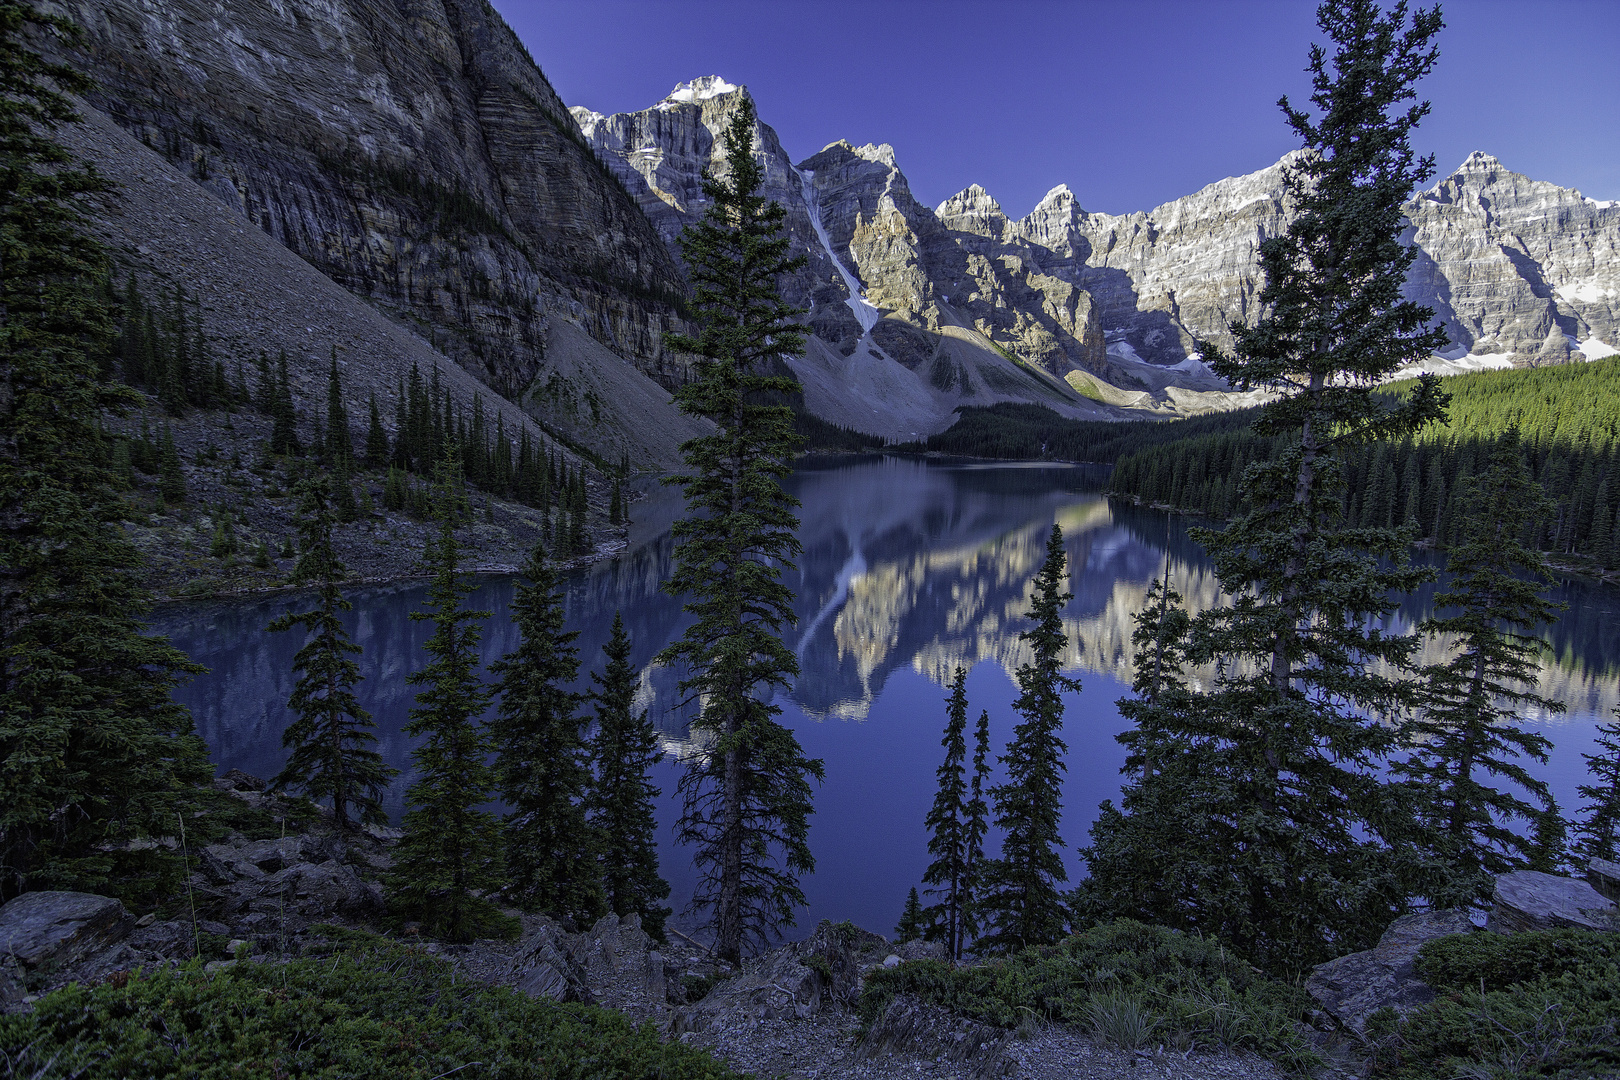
[42,0,1620,465]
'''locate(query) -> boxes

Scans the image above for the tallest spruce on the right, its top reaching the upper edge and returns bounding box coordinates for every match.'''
[1090,0,1445,972]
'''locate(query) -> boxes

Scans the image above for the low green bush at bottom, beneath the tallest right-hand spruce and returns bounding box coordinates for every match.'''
[860,918,1317,1070]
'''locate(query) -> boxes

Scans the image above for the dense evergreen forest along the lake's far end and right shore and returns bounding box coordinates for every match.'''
[902,359,1620,570]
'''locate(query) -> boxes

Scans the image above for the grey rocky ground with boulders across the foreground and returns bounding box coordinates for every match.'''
[0,771,1620,1080]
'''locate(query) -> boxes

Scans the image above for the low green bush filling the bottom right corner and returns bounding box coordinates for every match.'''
[1367,929,1620,1080]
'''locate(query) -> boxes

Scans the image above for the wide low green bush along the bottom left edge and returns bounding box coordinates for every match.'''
[0,946,739,1080]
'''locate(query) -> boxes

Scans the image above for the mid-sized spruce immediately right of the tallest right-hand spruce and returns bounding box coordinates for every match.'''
[1395,431,1563,907]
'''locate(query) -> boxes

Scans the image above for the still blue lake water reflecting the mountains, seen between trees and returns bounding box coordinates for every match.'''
[152,458,1620,933]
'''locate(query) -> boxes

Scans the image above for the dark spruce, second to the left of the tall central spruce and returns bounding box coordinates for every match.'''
[489,546,606,923]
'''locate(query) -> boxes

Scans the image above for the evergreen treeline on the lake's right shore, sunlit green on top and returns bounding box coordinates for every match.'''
[1110,359,1620,568]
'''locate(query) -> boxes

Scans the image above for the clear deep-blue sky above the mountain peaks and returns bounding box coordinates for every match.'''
[494,0,1620,217]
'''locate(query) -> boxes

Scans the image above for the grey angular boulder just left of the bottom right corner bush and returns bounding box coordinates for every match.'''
[1306,912,1474,1035]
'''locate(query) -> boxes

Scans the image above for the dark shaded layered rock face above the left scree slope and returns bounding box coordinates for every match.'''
[49,0,684,398]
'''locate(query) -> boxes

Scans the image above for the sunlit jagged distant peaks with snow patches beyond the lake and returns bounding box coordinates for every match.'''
[572,76,1620,434]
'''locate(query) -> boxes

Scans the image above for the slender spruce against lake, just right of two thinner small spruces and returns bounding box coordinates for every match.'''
[977,525,1081,954]
